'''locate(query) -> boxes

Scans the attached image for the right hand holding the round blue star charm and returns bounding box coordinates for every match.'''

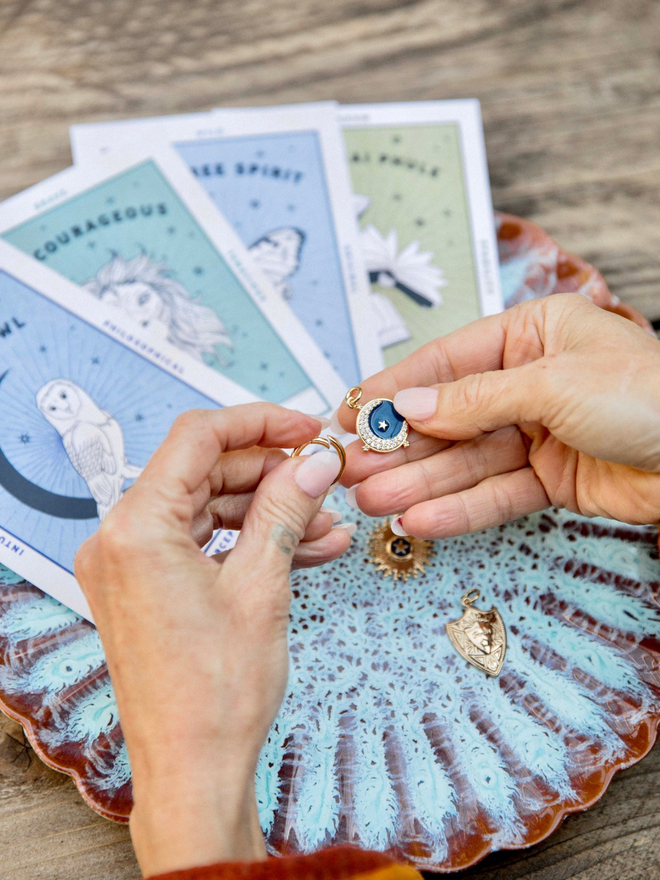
[338,294,660,538]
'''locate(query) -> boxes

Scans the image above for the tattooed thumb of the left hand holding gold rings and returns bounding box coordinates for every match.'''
[230,450,340,580]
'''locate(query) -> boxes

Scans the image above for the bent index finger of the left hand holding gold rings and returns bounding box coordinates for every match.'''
[136,403,324,498]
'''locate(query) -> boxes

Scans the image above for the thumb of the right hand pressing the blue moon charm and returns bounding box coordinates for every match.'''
[394,360,545,440]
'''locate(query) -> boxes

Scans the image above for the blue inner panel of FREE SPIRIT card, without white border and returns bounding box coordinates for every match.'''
[180,131,361,387]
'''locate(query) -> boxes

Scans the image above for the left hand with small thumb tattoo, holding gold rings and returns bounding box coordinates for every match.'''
[76,404,351,875]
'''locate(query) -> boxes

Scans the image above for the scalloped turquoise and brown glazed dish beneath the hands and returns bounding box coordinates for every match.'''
[0,215,660,871]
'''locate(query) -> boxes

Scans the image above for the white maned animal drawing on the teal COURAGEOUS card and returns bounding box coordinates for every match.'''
[83,254,234,367]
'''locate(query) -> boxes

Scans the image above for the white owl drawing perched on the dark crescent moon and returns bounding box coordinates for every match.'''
[37,379,142,521]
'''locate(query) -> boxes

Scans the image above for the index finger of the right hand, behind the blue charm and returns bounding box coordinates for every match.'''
[337,312,508,433]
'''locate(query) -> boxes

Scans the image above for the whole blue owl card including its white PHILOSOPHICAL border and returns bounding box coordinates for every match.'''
[0,242,255,619]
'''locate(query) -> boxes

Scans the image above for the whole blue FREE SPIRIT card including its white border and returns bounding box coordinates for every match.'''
[71,103,383,388]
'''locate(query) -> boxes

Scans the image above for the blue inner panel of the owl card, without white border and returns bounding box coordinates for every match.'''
[0,270,217,573]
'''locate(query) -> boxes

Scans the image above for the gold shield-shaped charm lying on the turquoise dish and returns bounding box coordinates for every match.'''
[446,589,506,676]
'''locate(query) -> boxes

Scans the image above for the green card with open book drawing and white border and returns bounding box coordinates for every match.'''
[339,100,503,366]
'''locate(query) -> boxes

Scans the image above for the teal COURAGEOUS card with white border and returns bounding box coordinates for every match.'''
[0,147,344,413]
